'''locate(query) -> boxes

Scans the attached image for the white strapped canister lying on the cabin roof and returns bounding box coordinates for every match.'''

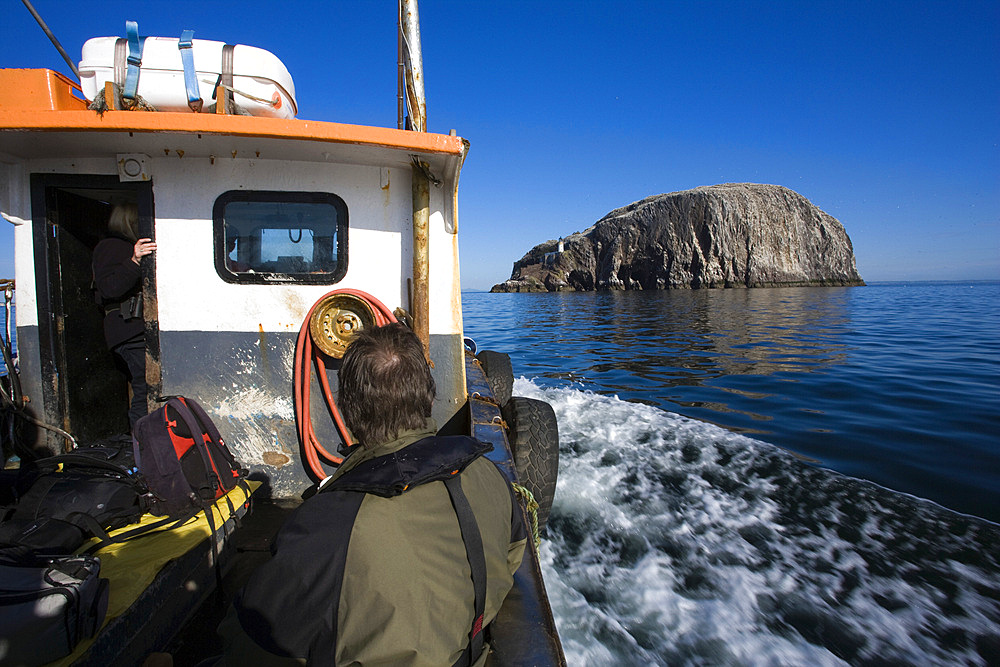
[80,37,297,118]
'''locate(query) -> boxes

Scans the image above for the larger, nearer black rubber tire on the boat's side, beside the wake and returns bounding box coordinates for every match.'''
[502,396,559,532]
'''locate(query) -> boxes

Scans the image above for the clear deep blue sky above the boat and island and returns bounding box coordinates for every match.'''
[0,0,1000,289]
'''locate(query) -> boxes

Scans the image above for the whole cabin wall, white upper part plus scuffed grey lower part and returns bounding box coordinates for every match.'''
[0,151,465,480]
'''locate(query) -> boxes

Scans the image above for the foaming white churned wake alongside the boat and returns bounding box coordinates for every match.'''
[514,379,1000,665]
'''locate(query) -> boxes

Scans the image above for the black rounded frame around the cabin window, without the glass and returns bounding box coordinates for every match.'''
[212,190,350,285]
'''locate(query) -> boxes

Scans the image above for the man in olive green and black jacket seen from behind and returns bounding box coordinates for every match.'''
[219,324,527,667]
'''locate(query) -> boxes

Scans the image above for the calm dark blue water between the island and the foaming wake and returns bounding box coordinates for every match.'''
[463,283,1000,521]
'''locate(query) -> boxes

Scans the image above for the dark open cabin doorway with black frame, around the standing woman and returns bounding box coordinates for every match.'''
[31,174,158,450]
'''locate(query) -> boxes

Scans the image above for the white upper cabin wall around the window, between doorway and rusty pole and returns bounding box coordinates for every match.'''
[151,157,412,332]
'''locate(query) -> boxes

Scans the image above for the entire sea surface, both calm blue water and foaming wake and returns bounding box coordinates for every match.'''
[463,283,1000,665]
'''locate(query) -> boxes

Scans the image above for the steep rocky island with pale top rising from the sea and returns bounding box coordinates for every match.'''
[491,183,864,292]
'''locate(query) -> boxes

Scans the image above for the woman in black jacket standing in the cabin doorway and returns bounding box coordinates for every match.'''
[94,204,156,429]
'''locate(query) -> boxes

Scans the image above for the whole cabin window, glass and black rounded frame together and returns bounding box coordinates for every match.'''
[213,190,347,284]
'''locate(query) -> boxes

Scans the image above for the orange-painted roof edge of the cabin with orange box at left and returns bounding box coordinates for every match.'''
[0,69,465,155]
